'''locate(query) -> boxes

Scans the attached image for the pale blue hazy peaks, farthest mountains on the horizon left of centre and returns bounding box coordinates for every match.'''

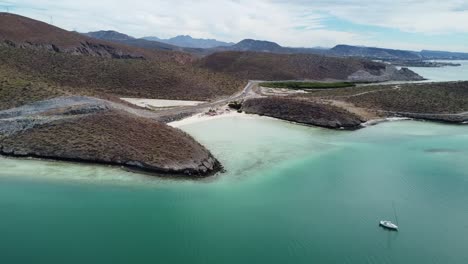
[143,35,235,49]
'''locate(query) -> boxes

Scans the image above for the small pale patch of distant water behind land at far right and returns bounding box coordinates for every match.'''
[410,60,468,82]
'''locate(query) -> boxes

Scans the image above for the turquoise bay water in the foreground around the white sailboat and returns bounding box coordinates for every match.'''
[0,117,468,263]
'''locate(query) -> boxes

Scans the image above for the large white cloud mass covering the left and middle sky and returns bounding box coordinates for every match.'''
[5,0,359,46]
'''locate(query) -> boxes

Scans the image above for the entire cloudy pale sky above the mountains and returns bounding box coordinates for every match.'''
[0,0,468,52]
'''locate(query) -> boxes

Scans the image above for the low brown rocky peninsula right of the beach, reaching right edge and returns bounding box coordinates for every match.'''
[242,82,468,129]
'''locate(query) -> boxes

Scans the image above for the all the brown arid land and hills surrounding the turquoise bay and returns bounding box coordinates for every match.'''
[0,13,468,177]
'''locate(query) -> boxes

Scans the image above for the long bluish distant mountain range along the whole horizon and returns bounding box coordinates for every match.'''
[85,31,468,61]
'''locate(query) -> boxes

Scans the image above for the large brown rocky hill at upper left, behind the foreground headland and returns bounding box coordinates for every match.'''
[0,13,247,104]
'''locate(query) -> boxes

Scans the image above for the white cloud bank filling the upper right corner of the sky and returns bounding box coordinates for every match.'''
[284,0,468,34]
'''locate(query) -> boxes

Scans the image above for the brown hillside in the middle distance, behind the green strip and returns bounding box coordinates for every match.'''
[199,52,394,80]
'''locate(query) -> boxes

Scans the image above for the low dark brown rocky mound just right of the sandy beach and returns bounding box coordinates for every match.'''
[242,97,365,129]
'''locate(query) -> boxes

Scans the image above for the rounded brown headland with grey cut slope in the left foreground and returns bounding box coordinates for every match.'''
[0,97,221,178]
